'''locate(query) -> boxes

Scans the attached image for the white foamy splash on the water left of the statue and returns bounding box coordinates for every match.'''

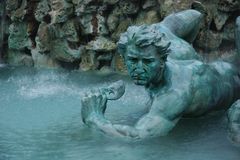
[8,71,86,99]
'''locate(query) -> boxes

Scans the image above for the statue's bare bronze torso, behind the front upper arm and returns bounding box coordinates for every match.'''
[155,59,240,115]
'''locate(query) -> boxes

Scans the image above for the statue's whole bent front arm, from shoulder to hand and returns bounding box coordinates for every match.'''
[82,90,187,138]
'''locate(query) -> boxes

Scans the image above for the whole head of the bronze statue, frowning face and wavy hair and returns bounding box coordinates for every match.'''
[118,25,170,86]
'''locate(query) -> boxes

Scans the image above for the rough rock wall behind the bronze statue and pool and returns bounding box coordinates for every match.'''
[0,0,240,71]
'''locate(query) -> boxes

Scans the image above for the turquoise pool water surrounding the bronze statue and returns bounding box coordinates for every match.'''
[0,67,240,160]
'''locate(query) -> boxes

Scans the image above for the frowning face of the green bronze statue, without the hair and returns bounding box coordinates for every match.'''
[124,45,165,85]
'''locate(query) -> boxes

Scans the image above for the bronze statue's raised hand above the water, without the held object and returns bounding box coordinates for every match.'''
[81,89,107,125]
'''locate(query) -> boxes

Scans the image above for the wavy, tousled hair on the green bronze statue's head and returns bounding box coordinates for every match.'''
[118,24,171,59]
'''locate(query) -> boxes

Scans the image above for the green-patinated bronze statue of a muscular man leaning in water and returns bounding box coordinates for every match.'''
[82,10,240,138]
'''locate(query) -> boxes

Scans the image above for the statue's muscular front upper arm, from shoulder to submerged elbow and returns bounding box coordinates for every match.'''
[129,90,188,138]
